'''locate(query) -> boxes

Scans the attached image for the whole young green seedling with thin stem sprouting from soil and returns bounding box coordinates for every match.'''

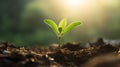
[44,18,81,47]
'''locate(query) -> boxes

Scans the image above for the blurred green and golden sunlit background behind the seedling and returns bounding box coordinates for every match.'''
[0,0,120,45]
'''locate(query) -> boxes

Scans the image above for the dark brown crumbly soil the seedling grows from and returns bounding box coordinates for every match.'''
[0,38,120,67]
